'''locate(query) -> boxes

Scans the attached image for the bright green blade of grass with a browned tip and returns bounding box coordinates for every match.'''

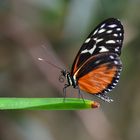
[0,98,99,110]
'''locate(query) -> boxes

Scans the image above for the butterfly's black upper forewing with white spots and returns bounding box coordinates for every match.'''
[71,18,124,75]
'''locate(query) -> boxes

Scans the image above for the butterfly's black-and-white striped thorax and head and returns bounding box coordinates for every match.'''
[61,70,77,88]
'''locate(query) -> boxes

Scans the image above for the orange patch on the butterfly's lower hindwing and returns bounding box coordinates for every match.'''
[78,64,118,94]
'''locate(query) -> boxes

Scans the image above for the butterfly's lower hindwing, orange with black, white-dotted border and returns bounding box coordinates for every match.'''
[74,53,122,94]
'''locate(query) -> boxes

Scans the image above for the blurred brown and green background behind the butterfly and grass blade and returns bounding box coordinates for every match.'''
[0,0,140,140]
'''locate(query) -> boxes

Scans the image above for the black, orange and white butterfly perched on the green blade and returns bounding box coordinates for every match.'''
[61,18,124,102]
